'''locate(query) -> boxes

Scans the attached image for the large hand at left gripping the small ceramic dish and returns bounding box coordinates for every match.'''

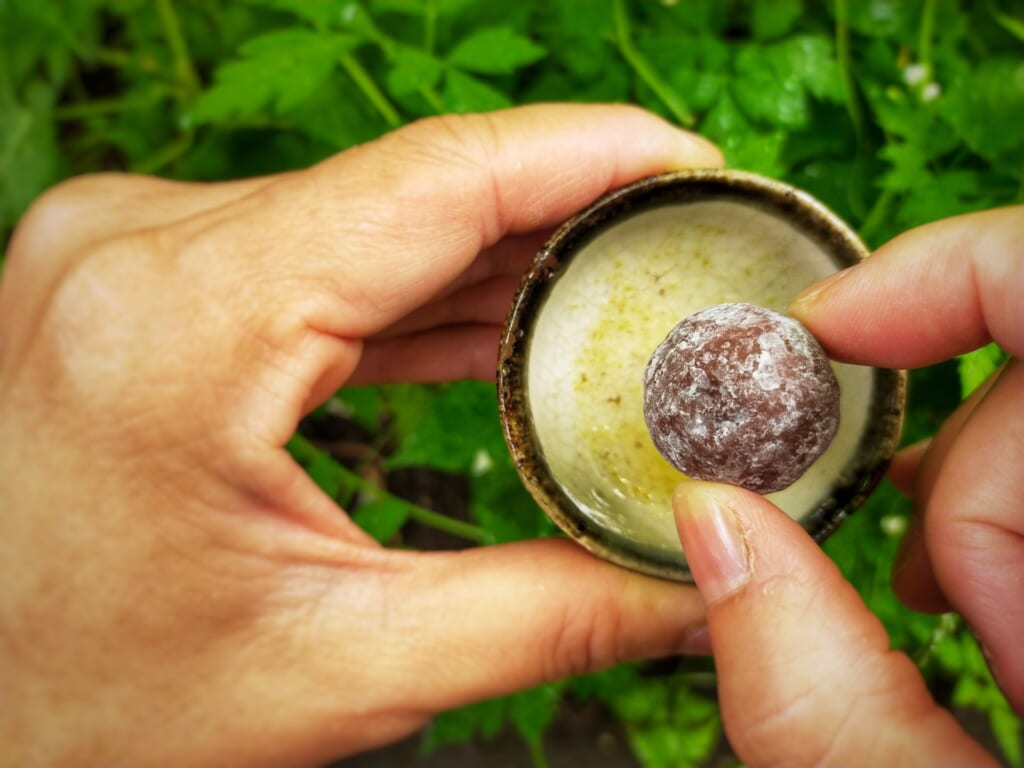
[0,106,721,767]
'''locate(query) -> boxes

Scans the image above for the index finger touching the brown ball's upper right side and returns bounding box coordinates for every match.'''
[791,206,1024,368]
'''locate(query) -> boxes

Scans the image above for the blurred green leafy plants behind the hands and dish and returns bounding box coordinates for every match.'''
[0,0,1024,768]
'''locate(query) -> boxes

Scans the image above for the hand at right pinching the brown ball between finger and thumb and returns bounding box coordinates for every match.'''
[675,208,1024,768]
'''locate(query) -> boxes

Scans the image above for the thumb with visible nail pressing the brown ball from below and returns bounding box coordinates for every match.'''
[674,482,994,768]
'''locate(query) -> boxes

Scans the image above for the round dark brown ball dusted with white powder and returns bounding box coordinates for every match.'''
[643,304,839,494]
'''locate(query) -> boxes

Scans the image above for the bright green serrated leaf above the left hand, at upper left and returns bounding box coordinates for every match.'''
[188,29,358,125]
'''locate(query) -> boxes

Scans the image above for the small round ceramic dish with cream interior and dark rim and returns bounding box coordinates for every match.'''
[498,170,906,582]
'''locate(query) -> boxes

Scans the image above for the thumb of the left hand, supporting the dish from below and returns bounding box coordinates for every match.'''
[380,540,703,711]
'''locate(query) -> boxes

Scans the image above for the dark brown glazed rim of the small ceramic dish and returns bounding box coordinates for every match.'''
[498,170,906,582]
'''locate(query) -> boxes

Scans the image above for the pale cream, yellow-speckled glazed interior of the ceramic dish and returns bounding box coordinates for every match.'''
[526,200,871,560]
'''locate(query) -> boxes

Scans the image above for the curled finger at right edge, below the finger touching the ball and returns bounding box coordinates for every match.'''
[924,360,1024,711]
